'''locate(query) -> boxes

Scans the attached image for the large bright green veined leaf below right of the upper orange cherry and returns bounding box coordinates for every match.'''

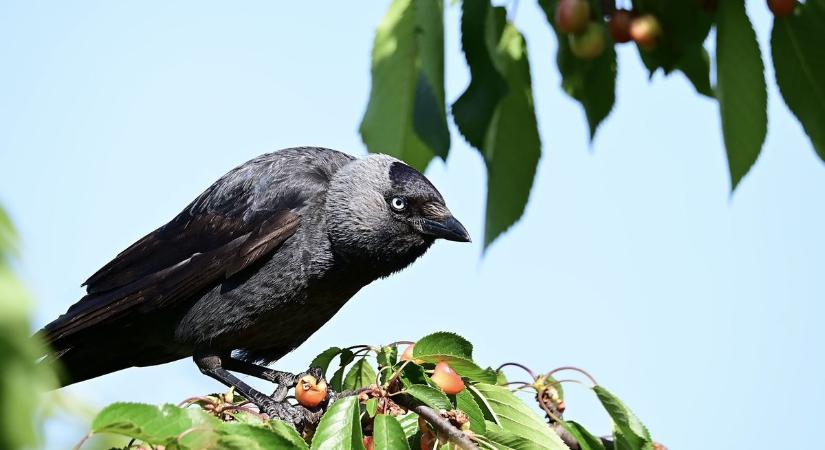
[468,383,567,450]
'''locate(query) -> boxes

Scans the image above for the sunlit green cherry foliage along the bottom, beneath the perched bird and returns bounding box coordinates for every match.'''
[74,332,654,450]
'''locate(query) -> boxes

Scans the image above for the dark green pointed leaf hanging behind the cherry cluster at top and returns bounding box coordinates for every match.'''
[539,0,617,140]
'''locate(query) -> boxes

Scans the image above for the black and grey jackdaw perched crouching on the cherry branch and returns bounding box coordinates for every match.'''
[36,147,471,420]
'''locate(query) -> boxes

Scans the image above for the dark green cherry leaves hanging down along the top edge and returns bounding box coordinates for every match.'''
[361,0,825,247]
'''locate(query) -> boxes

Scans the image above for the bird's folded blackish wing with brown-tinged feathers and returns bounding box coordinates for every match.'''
[41,149,351,347]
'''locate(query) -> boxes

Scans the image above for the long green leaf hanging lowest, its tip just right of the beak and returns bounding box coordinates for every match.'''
[482,8,541,248]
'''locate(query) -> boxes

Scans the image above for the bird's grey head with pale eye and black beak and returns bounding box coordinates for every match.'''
[326,155,470,271]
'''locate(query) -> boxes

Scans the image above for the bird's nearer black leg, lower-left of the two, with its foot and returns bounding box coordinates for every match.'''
[194,353,321,430]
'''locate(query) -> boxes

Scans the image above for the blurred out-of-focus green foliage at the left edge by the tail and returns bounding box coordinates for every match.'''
[0,208,53,449]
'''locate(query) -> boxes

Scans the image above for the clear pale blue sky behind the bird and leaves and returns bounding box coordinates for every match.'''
[0,1,825,449]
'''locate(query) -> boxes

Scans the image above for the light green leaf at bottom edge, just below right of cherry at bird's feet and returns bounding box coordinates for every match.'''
[312,396,364,450]
